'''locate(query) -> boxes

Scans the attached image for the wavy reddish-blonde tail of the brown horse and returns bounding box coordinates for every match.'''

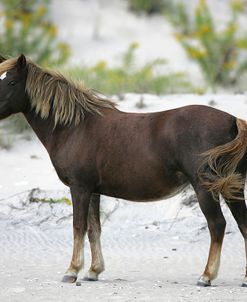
[199,119,247,201]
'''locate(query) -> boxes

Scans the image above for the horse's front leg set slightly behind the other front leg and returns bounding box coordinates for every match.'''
[84,194,105,281]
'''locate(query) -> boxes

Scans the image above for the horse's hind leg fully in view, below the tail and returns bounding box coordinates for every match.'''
[197,189,226,286]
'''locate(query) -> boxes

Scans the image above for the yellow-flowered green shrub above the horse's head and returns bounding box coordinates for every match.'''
[0,0,69,65]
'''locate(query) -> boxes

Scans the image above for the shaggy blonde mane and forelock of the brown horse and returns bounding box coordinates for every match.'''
[0,59,116,125]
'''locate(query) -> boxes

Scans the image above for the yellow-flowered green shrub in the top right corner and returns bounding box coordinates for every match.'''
[175,0,247,88]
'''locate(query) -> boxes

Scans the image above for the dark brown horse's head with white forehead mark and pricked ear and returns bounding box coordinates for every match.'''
[0,55,27,119]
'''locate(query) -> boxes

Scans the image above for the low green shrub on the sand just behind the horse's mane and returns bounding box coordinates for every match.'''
[65,43,193,95]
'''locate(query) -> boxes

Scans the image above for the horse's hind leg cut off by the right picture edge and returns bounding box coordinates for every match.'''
[227,190,247,287]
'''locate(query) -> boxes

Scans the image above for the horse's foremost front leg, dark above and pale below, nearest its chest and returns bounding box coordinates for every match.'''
[62,186,91,283]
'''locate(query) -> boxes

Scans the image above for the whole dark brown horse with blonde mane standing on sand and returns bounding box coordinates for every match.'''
[0,55,247,286]
